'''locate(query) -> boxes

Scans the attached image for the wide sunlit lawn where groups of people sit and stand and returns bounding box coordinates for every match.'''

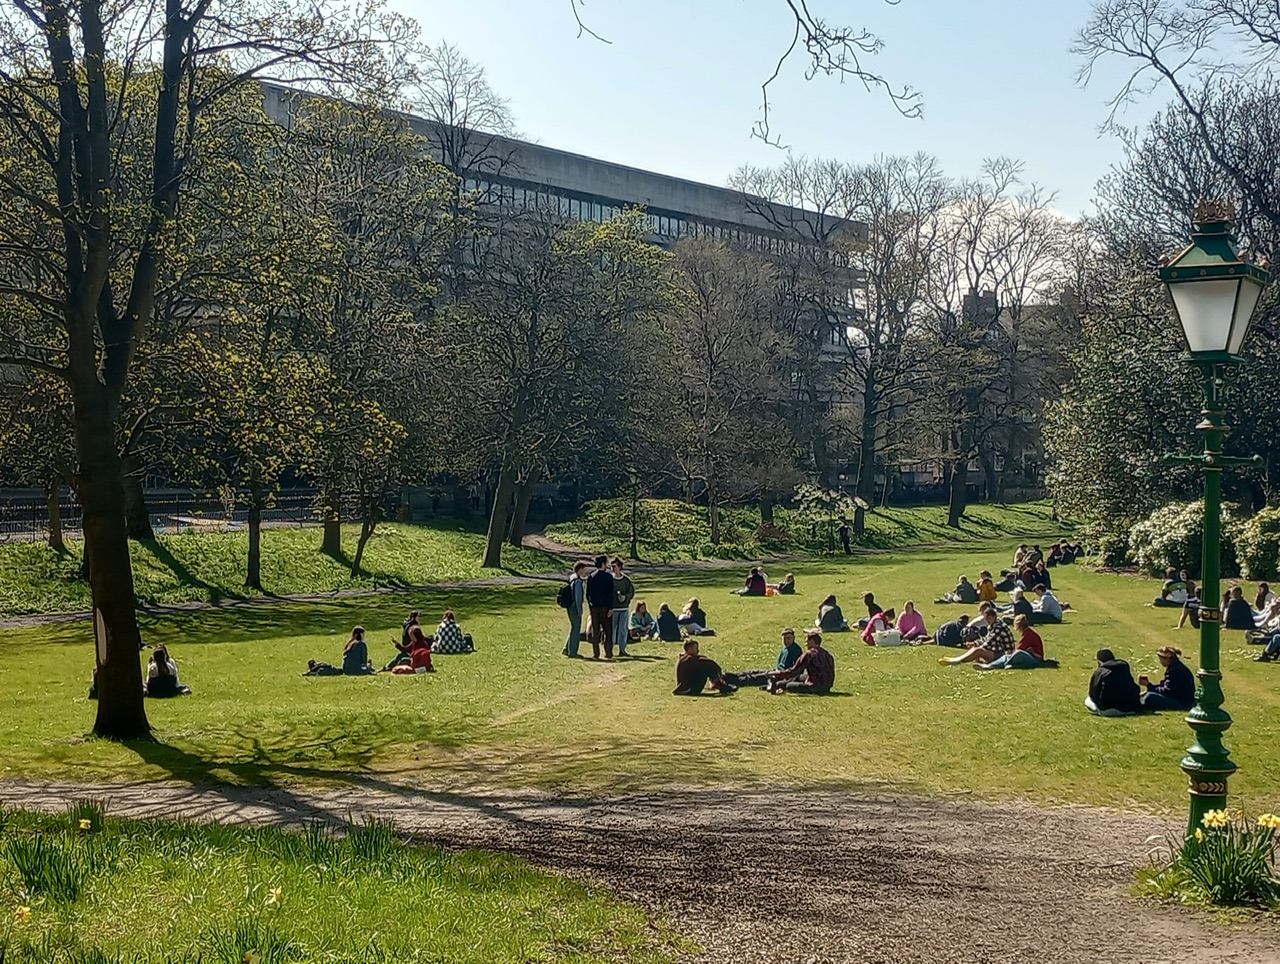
[0,543,1280,809]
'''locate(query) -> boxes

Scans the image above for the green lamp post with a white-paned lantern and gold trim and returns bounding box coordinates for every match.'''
[1160,201,1270,835]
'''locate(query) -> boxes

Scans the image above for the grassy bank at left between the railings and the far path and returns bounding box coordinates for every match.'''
[0,520,559,616]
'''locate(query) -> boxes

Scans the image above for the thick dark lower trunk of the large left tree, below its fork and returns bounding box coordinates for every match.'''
[72,373,151,740]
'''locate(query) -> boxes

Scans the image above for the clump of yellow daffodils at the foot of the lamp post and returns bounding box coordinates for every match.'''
[1139,810,1280,908]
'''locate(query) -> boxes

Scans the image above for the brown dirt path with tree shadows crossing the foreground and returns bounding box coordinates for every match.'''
[0,780,1280,964]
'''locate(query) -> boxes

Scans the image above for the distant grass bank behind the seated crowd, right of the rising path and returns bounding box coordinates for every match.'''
[547,499,1065,562]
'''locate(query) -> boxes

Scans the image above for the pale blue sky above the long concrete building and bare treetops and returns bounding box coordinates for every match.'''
[393,0,1160,215]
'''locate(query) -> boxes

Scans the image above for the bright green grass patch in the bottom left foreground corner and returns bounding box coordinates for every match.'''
[0,808,684,964]
